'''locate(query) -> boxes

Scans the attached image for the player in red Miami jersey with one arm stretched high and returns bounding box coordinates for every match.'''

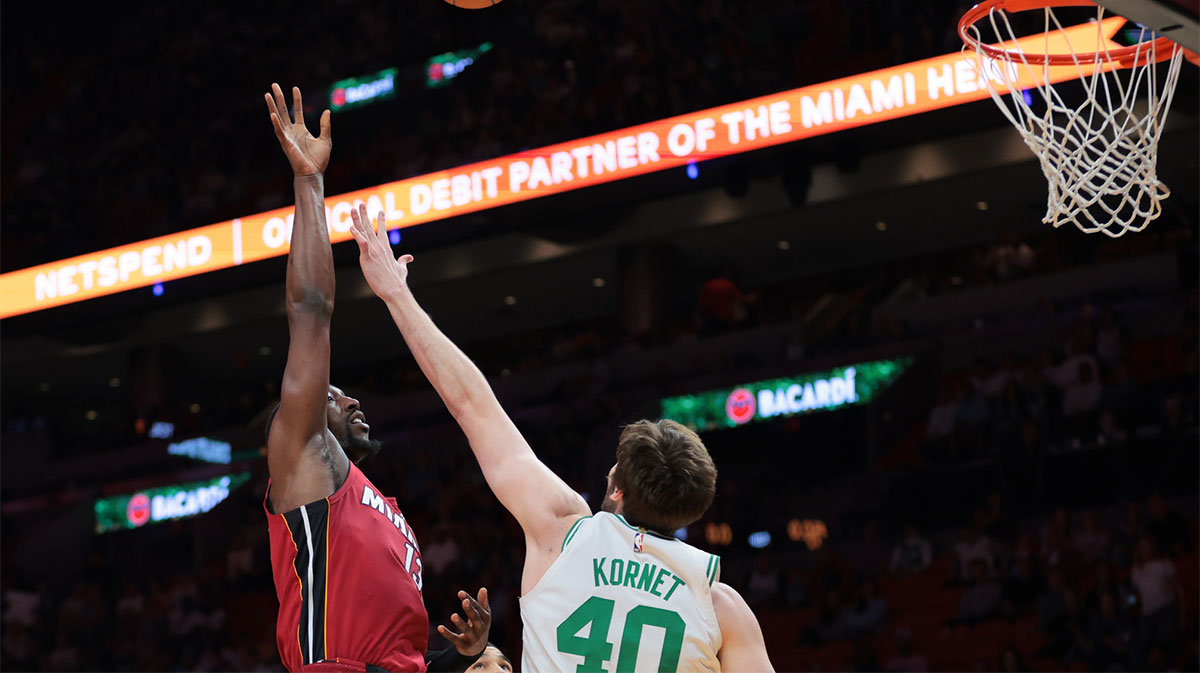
[264,84,491,673]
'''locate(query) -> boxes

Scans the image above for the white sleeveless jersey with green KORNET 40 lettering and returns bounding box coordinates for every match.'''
[521,512,721,673]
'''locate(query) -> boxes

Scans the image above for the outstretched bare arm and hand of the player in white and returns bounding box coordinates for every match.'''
[352,206,592,559]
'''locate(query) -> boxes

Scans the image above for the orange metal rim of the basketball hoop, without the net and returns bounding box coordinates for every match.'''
[959,0,1187,67]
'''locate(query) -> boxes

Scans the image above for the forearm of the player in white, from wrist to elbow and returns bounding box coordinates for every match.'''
[384,284,493,419]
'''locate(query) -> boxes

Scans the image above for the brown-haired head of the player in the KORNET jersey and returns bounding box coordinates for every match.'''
[600,420,716,535]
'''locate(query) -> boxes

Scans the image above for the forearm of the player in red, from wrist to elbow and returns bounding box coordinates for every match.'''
[287,174,334,313]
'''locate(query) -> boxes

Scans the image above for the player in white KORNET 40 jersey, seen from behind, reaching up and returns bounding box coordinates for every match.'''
[352,206,773,673]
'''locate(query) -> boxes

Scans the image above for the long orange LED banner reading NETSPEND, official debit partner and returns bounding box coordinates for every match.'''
[0,17,1123,318]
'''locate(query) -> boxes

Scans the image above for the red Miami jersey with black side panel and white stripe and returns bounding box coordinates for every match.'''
[264,462,430,673]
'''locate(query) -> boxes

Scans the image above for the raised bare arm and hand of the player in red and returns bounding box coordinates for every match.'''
[265,84,334,503]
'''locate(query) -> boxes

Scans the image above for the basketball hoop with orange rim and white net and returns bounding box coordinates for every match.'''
[959,0,1194,238]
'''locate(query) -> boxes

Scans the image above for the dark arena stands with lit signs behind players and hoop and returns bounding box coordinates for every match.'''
[0,0,1200,672]
